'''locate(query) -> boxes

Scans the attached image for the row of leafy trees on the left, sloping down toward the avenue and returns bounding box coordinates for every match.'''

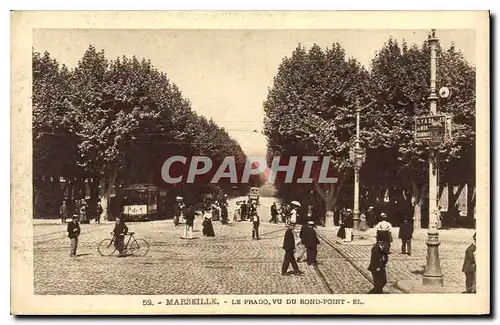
[33,46,254,218]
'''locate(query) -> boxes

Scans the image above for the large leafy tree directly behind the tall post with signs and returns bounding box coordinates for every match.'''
[368,39,475,228]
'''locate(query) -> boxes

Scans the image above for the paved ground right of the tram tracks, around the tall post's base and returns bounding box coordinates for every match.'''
[317,227,474,293]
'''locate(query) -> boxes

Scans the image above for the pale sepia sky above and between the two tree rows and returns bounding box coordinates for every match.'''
[33,29,476,156]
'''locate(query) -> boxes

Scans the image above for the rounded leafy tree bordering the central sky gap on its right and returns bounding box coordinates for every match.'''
[264,43,369,215]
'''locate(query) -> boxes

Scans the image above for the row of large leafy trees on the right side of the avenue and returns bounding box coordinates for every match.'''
[264,39,475,227]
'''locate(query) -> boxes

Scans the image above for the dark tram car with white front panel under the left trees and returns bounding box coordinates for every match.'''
[122,184,166,221]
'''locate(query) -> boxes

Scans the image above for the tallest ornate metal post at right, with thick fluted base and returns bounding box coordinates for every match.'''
[423,29,443,286]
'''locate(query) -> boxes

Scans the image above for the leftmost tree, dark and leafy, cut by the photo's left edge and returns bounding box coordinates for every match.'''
[32,51,77,214]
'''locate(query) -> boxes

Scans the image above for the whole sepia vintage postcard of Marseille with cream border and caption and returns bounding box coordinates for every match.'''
[11,11,491,315]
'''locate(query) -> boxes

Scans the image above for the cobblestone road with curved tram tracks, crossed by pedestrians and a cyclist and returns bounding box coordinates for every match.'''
[34,196,467,295]
